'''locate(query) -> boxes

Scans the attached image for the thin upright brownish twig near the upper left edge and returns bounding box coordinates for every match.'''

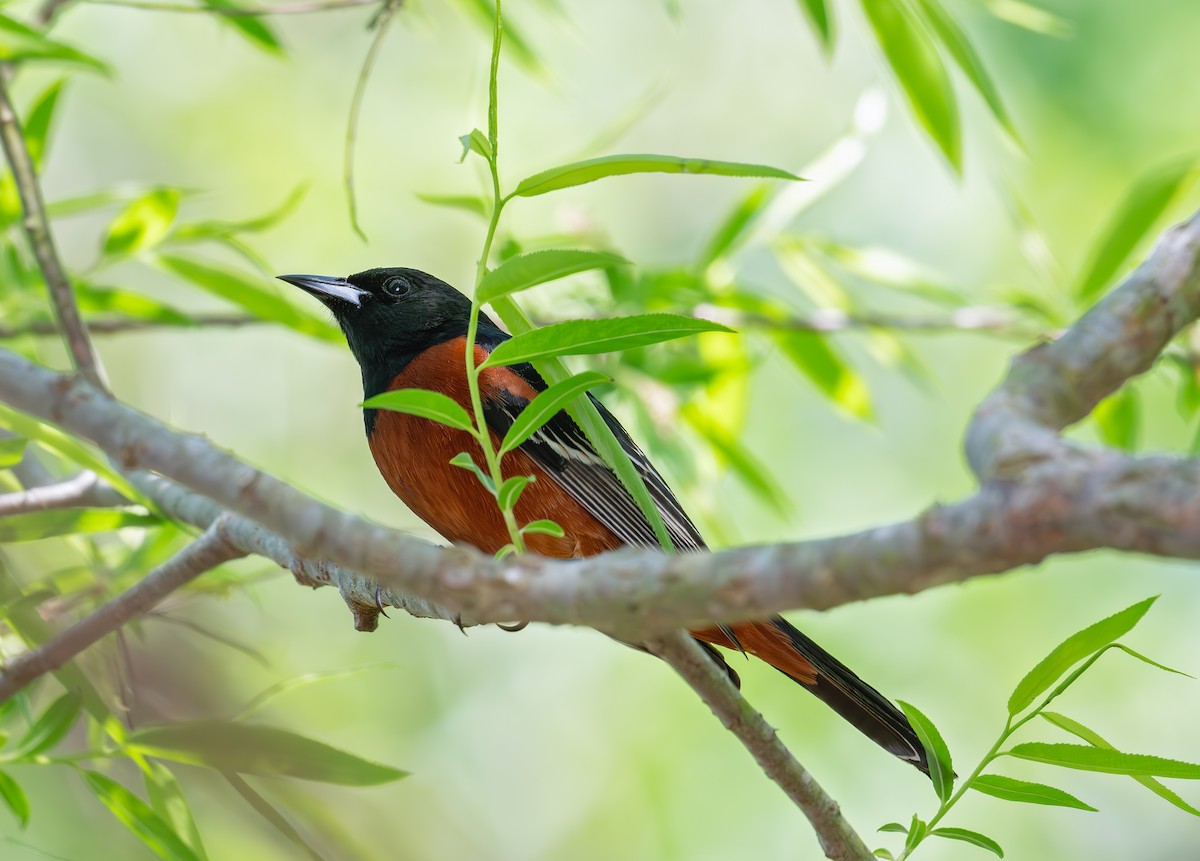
[0,77,107,389]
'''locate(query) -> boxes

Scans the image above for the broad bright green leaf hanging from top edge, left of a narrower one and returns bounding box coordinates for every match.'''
[862,0,962,173]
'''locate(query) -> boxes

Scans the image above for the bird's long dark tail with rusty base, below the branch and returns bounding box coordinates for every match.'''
[697,616,929,775]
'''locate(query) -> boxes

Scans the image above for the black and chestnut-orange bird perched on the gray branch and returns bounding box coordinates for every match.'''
[280,269,929,773]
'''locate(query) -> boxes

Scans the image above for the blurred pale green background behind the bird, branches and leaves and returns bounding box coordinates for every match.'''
[0,0,1200,861]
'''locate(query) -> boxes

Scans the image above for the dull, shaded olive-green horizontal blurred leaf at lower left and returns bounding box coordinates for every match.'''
[126,721,408,787]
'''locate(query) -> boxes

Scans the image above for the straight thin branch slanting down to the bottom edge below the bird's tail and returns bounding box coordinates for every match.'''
[647,631,874,861]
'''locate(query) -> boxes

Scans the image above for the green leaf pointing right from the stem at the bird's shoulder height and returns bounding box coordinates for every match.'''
[481,314,733,368]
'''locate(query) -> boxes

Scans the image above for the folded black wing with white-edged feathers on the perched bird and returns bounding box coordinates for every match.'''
[484,365,704,550]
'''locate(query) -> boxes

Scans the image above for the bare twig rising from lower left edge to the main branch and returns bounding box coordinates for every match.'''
[0,519,245,703]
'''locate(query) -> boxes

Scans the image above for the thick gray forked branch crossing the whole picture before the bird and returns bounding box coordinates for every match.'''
[0,202,1200,642]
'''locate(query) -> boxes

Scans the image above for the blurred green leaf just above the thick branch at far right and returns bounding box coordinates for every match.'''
[1075,158,1195,302]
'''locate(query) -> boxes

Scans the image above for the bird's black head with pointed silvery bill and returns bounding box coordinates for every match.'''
[280,269,503,397]
